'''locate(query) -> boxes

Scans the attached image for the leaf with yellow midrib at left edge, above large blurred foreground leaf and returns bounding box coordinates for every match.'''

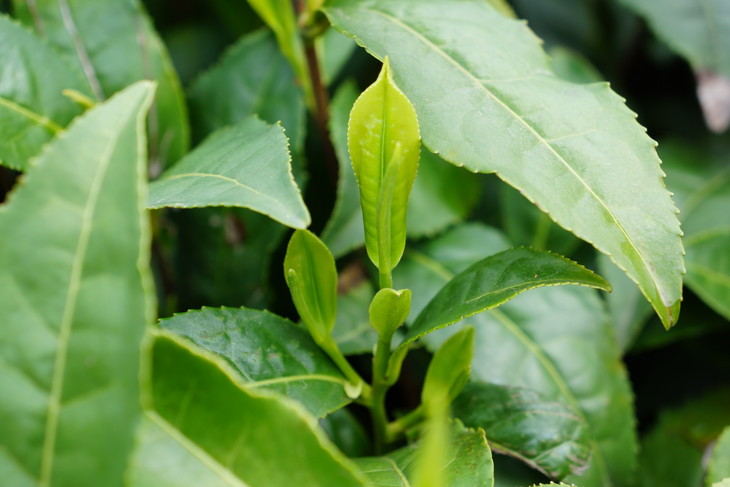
[0,15,89,170]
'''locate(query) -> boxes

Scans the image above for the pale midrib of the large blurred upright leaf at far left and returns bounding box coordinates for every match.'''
[38,100,135,487]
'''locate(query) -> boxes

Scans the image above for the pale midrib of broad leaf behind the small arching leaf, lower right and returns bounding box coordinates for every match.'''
[406,252,613,486]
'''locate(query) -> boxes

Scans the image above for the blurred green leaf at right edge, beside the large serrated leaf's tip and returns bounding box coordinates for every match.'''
[661,141,730,318]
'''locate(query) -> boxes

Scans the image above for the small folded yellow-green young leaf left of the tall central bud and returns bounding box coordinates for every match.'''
[284,230,337,344]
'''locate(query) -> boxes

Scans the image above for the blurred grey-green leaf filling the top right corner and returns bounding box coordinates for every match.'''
[622,0,730,76]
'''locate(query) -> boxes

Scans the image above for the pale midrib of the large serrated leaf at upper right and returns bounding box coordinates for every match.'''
[363,4,666,304]
